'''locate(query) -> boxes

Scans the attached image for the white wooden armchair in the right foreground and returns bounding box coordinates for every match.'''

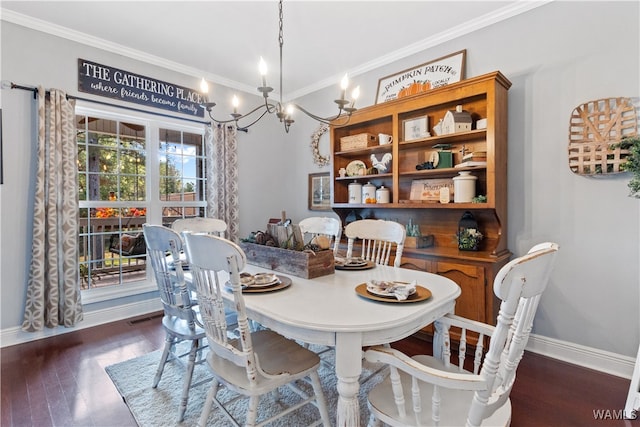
[365,243,558,426]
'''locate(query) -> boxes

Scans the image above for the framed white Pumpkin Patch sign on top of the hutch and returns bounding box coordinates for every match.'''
[376,49,467,104]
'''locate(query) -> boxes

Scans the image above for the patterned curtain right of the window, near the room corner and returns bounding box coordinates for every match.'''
[205,125,240,243]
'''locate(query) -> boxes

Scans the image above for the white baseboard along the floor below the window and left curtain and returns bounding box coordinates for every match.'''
[0,298,162,347]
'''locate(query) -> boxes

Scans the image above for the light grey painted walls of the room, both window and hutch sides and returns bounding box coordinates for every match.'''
[0,2,640,364]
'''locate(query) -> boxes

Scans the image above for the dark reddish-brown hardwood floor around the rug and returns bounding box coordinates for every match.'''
[0,316,640,427]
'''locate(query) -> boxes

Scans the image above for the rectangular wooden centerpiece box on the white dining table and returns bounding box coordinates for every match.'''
[240,242,335,279]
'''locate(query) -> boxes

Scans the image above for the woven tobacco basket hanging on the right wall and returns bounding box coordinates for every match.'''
[569,98,638,176]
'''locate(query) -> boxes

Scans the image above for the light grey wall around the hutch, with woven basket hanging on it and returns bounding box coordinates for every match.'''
[291,2,640,358]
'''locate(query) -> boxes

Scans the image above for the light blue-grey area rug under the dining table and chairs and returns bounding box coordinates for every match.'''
[105,347,382,427]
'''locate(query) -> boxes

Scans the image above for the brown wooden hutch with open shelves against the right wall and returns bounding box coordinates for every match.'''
[331,71,511,324]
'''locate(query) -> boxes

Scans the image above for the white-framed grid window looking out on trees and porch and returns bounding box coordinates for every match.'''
[76,108,206,300]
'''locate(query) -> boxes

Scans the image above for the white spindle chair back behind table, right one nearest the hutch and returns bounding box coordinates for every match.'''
[344,219,406,267]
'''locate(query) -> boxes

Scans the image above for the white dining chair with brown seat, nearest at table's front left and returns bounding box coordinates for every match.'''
[180,234,330,426]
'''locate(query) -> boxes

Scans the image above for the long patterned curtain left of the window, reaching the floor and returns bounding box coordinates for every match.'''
[22,87,82,332]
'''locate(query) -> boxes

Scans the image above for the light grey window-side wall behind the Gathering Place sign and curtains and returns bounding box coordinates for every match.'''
[0,21,289,339]
